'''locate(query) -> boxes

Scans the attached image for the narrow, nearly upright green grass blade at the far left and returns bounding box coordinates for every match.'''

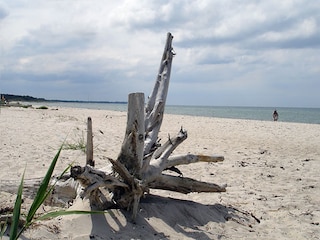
[10,170,25,240]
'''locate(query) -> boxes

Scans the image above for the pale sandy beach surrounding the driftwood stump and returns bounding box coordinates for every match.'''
[0,107,320,239]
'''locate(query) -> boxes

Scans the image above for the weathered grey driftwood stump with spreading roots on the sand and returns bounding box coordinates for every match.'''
[71,33,226,220]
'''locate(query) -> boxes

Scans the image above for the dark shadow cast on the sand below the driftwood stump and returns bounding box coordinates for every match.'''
[90,195,259,240]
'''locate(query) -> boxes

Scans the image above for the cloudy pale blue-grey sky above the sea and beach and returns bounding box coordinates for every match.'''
[0,0,320,108]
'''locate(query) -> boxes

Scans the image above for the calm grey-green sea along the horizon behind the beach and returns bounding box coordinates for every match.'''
[37,102,320,124]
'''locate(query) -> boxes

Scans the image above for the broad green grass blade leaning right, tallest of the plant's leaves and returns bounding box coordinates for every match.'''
[26,145,63,225]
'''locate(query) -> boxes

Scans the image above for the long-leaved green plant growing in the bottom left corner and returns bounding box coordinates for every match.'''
[7,145,105,240]
